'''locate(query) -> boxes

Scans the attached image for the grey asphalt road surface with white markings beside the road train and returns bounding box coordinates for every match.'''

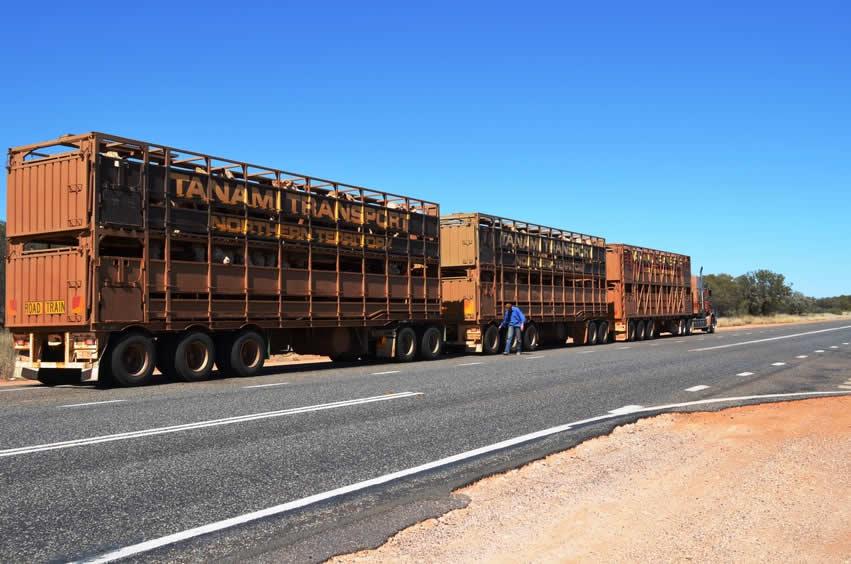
[0,321,851,562]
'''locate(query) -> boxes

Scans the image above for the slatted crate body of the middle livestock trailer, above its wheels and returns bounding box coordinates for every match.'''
[441,213,607,324]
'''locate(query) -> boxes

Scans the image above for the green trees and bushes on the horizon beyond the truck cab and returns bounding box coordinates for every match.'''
[705,270,851,317]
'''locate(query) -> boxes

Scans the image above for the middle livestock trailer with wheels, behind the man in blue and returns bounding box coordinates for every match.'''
[440,213,610,354]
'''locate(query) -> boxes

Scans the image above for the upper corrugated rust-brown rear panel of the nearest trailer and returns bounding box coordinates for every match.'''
[7,145,89,238]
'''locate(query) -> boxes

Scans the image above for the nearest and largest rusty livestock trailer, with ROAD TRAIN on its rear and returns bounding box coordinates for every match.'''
[5,133,443,385]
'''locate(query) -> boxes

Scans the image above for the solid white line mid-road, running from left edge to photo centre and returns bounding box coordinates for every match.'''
[0,392,422,458]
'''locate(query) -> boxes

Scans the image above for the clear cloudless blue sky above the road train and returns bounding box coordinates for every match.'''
[0,0,851,296]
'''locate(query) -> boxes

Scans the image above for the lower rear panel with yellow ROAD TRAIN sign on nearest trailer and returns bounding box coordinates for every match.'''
[6,243,88,328]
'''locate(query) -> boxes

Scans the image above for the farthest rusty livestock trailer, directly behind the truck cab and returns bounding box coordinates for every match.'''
[606,243,693,341]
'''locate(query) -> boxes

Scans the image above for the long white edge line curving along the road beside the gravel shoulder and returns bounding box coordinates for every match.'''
[75,391,851,563]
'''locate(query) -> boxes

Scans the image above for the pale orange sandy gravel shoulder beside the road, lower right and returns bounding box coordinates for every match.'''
[332,397,851,563]
